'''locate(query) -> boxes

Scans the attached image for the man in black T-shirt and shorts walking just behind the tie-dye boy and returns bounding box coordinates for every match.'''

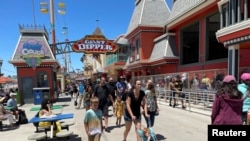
[92,77,114,132]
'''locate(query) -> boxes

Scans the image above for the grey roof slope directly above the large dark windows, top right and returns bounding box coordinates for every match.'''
[167,0,206,23]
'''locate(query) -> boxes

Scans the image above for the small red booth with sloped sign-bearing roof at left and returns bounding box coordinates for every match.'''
[9,26,59,104]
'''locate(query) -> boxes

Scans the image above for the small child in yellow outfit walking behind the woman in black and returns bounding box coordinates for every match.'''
[115,96,125,127]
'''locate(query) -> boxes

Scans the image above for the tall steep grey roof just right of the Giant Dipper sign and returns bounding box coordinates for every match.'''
[126,0,170,35]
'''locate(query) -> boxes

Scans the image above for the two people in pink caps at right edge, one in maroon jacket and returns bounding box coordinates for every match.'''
[211,73,250,125]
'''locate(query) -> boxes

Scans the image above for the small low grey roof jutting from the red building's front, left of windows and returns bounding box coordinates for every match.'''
[149,34,178,62]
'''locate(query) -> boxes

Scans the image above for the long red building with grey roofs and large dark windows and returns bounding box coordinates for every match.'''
[120,0,250,84]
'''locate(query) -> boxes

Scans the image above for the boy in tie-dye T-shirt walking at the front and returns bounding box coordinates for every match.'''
[83,97,102,141]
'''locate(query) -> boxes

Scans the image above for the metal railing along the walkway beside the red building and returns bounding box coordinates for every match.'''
[156,87,216,115]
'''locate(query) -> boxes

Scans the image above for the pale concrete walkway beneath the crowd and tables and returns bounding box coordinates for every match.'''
[0,96,210,141]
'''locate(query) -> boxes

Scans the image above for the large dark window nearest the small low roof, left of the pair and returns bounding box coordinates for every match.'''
[181,22,200,64]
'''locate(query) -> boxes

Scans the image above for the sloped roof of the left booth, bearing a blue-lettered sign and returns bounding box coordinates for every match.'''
[9,27,59,68]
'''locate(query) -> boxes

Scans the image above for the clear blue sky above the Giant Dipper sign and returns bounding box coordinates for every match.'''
[0,0,172,76]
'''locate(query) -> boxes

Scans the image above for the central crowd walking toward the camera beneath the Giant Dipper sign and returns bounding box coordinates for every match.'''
[64,76,159,141]
